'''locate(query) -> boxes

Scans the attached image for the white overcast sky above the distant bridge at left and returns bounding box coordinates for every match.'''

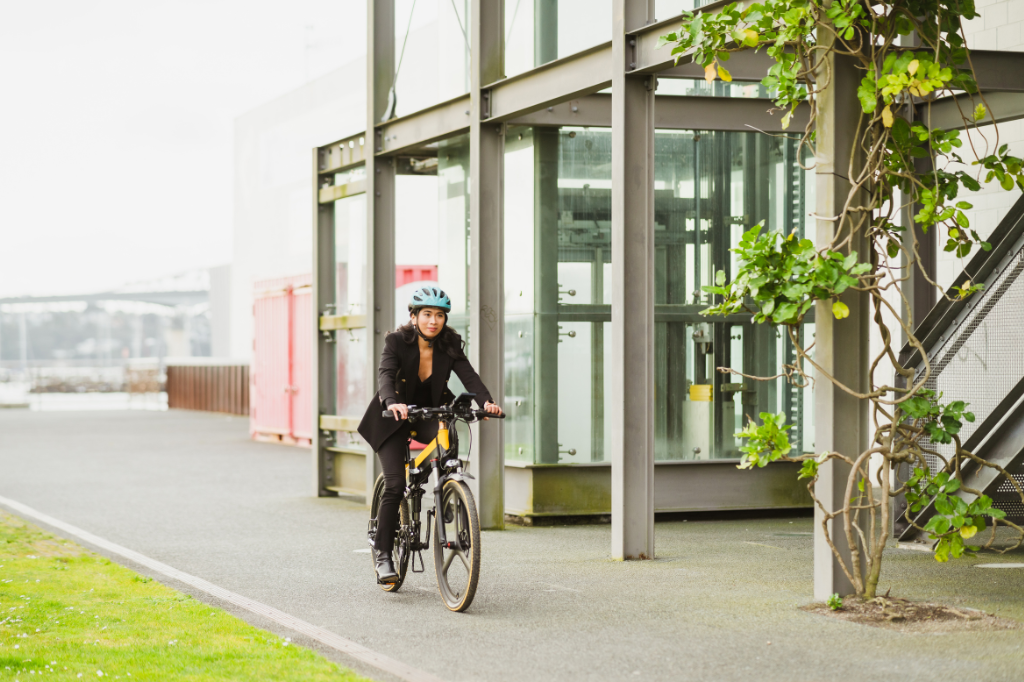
[0,0,366,297]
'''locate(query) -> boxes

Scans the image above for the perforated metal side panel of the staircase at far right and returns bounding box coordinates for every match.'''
[916,223,1024,517]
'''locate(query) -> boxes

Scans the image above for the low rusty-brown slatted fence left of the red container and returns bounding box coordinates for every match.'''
[167,365,249,415]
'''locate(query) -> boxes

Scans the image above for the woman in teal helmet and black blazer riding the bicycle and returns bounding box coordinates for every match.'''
[358,287,502,583]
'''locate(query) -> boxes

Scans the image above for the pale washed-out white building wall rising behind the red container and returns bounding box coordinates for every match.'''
[228,58,367,359]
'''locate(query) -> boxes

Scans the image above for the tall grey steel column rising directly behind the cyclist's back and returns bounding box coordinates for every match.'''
[362,0,395,496]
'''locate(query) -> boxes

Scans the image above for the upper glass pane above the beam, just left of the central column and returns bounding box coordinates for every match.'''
[505,0,606,76]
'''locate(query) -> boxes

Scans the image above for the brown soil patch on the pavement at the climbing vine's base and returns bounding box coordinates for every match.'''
[801,597,1024,633]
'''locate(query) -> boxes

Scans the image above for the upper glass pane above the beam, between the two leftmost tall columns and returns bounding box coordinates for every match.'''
[394,0,470,116]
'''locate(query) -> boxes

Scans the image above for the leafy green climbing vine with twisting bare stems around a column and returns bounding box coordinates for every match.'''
[660,0,1024,598]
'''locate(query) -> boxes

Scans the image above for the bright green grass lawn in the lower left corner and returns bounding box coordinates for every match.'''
[0,511,376,682]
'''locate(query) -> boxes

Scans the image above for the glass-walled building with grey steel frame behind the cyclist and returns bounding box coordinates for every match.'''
[314,0,831,527]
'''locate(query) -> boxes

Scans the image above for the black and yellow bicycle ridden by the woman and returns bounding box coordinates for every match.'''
[367,393,505,611]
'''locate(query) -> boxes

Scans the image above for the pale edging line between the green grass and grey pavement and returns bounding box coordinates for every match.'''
[0,497,442,682]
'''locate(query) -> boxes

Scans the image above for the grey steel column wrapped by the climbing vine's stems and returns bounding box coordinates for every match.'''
[814,47,870,601]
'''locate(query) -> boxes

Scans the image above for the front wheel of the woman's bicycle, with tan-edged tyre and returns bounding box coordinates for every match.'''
[433,480,480,611]
